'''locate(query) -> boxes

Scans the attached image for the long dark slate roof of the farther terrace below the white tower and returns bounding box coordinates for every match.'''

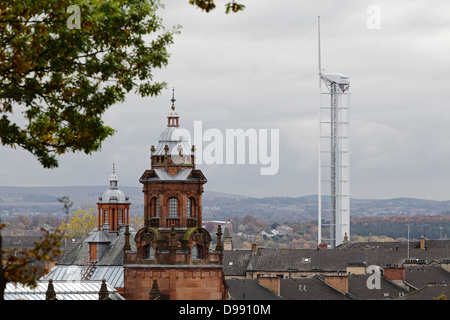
[229,240,450,275]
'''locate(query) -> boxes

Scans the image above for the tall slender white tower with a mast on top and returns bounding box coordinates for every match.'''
[318,17,350,248]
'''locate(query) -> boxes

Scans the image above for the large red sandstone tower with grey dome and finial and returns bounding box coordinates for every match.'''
[124,92,227,300]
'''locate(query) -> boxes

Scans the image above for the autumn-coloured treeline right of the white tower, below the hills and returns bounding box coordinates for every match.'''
[350,216,450,239]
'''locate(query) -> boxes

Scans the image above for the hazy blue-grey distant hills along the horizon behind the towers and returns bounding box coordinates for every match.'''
[0,186,450,223]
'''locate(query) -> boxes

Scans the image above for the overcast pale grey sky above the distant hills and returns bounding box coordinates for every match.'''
[0,0,450,200]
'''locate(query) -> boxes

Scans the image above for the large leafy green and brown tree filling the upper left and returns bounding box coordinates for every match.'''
[0,0,179,168]
